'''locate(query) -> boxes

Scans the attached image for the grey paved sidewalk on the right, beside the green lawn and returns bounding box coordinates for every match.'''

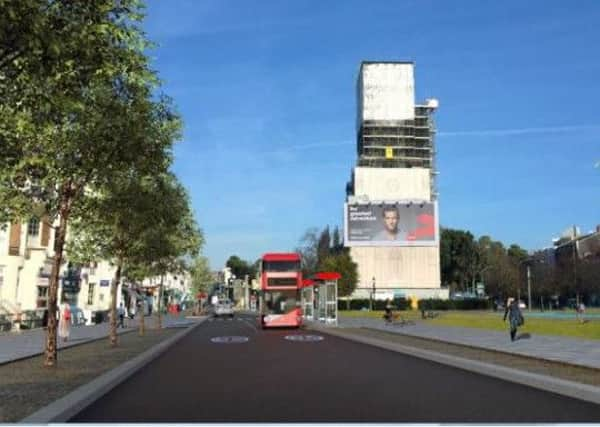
[338,315,600,369]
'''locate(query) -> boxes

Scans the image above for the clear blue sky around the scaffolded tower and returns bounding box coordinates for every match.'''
[145,0,600,269]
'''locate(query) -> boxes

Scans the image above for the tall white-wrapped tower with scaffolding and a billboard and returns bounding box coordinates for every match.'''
[344,62,448,299]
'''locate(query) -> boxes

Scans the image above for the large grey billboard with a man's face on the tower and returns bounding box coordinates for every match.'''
[344,201,439,246]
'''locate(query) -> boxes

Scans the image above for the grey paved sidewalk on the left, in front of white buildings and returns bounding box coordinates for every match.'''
[0,315,197,364]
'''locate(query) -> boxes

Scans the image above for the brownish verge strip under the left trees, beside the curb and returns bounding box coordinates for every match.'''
[0,328,181,423]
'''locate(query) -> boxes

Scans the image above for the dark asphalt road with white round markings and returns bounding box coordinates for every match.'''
[71,315,600,423]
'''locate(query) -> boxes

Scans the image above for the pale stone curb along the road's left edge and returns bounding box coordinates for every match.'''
[19,319,206,424]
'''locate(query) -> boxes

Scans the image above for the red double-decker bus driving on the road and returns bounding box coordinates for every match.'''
[259,253,302,328]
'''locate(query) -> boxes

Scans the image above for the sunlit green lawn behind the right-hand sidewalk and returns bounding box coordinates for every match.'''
[340,309,600,340]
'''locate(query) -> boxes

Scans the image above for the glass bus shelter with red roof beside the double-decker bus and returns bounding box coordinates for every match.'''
[301,272,341,325]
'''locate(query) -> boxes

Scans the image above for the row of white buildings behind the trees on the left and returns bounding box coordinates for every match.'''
[0,219,191,330]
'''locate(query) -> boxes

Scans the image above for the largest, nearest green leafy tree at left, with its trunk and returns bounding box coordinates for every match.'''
[0,0,172,366]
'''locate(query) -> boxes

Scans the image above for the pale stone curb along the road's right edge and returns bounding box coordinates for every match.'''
[310,325,600,404]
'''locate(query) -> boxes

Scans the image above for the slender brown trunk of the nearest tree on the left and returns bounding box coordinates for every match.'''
[44,194,71,367]
